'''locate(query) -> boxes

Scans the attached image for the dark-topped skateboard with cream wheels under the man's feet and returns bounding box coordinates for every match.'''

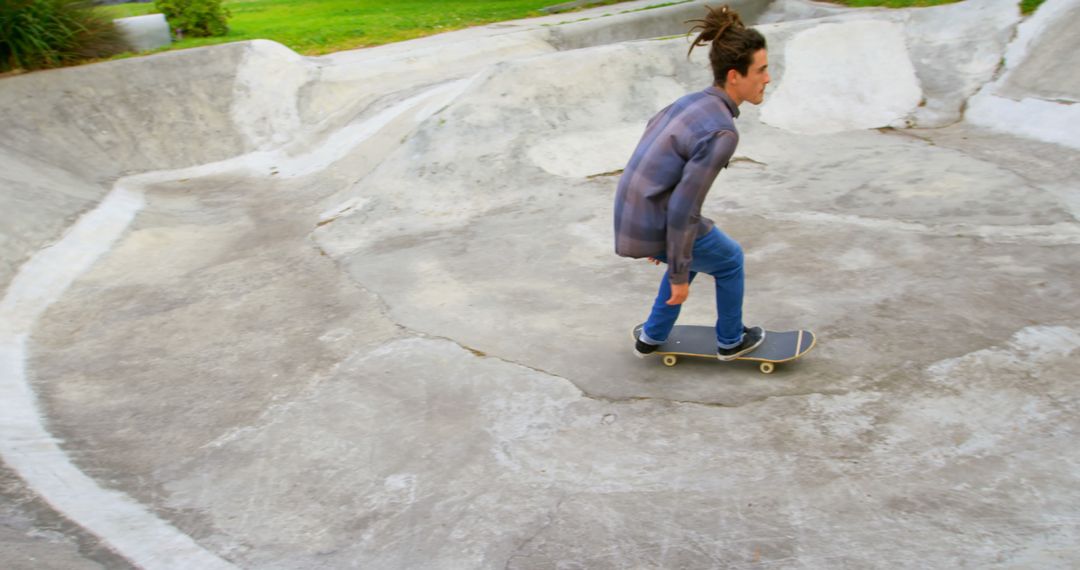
[634,325,818,374]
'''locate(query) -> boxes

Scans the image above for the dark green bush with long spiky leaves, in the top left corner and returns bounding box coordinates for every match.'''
[0,0,131,72]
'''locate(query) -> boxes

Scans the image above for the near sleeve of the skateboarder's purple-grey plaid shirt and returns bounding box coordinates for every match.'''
[667,131,739,285]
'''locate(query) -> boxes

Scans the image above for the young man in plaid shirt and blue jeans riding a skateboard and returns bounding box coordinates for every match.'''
[615,5,769,361]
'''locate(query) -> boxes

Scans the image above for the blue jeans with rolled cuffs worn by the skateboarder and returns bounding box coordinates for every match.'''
[642,227,743,349]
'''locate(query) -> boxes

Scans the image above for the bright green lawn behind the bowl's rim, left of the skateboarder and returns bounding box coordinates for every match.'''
[97,0,639,55]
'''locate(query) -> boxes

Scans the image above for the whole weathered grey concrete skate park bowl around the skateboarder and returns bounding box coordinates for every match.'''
[0,0,1080,569]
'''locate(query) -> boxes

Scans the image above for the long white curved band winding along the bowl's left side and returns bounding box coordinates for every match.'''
[0,80,471,570]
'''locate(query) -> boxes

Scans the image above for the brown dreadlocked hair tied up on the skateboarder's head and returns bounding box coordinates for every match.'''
[686,4,766,86]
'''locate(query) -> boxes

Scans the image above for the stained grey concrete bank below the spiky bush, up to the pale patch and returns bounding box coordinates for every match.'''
[0,45,245,287]
